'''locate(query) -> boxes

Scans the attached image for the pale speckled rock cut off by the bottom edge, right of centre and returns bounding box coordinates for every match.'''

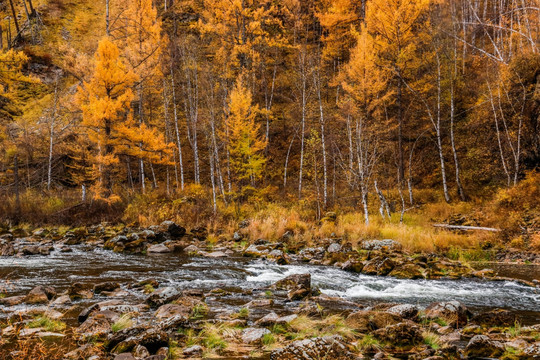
[270,336,356,360]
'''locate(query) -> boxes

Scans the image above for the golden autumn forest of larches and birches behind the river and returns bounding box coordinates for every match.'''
[0,0,540,245]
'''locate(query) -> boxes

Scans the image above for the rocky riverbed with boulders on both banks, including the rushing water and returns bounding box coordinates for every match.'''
[0,222,540,360]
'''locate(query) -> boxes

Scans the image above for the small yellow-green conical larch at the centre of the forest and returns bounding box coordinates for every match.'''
[227,76,266,190]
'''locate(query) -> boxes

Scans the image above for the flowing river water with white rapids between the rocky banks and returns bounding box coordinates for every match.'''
[0,247,540,323]
